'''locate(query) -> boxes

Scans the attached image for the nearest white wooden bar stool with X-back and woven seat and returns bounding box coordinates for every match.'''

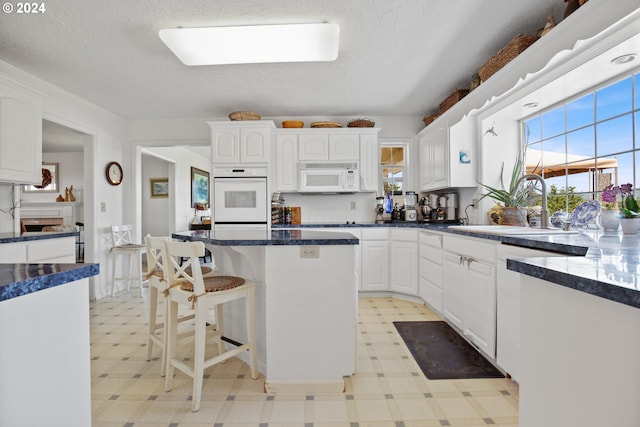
[163,242,258,412]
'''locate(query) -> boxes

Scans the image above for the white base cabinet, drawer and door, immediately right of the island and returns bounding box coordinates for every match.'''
[360,227,390,291]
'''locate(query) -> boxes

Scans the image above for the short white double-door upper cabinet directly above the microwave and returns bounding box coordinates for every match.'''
[298,130,360,162]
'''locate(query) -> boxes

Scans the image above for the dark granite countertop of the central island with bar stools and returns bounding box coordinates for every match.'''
[171,227,359,246]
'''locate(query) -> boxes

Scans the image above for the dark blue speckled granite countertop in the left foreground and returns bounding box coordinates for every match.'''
[0,264,100,301]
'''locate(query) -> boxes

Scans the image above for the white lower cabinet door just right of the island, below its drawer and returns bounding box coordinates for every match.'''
[360,240,389,291]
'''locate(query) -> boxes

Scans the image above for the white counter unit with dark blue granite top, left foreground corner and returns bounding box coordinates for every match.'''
[0,260,100,427]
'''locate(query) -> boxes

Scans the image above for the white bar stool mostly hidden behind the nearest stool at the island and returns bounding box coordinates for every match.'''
[144,235,218,376]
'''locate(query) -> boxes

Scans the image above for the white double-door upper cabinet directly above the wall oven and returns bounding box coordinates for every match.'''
[208,120,274,164]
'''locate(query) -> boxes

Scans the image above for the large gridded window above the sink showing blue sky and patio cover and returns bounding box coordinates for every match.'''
[523,74,640,213]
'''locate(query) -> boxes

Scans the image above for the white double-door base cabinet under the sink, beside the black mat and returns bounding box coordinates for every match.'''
[443,234,498,358]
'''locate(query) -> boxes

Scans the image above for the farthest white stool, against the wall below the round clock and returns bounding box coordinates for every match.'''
[110,225,145,296]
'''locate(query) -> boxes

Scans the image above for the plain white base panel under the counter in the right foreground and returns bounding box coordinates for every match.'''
[520,275,640,427]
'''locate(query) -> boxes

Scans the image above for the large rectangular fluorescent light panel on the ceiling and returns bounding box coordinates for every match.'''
[159,23,340,65]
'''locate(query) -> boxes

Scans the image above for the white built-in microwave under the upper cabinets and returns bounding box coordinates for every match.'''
[298,163,360,193]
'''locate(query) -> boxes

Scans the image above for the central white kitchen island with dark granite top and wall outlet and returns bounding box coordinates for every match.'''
[172,227,359,393]
